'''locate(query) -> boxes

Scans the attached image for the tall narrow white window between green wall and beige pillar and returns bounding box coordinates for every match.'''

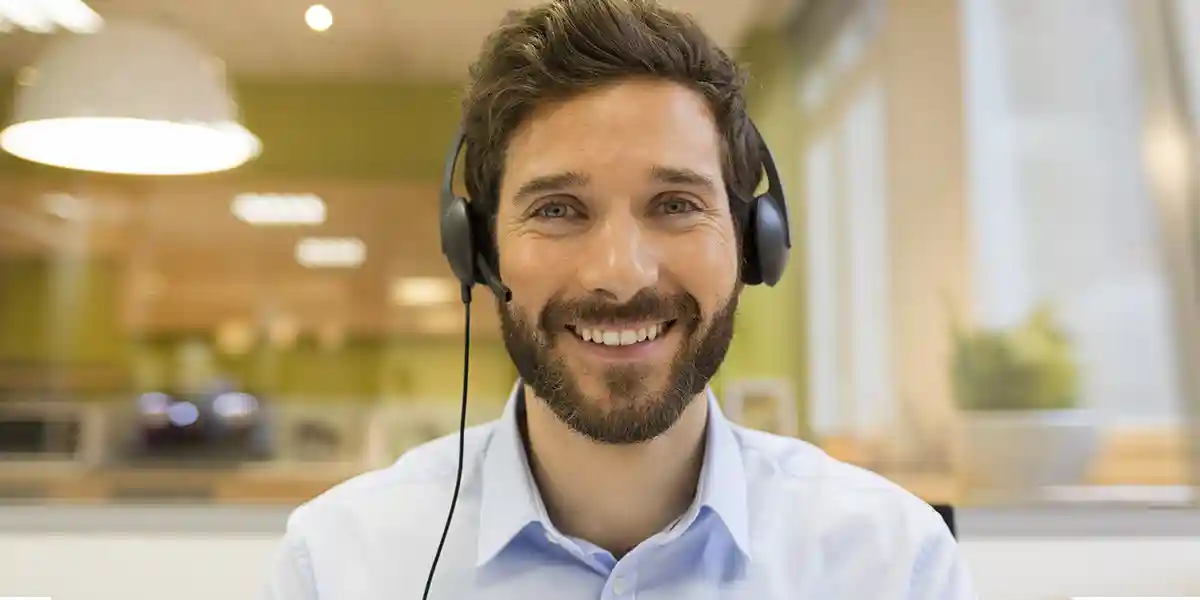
[800,1,895,446]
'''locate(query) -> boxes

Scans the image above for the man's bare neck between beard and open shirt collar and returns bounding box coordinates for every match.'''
[526,388,708,557]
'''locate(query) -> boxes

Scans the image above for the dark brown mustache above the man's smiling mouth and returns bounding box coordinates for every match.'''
[538,288,700,331]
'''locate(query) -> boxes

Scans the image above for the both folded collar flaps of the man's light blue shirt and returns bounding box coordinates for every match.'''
[476,380,750,566]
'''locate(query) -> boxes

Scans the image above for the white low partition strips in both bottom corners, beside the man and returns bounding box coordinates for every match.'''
[0,533,1200,600]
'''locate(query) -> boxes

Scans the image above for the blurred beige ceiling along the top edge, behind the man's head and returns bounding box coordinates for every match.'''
[0,0,792,80]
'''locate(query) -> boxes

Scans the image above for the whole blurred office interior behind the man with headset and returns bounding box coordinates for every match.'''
[0,0,1200,600]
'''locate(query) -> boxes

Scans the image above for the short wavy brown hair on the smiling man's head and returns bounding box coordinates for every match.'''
[462,0,762,248]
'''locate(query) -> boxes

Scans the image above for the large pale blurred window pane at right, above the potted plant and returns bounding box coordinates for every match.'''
[960,0,1181,422]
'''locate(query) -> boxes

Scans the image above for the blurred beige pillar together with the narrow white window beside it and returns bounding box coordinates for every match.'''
[793,0,970,469]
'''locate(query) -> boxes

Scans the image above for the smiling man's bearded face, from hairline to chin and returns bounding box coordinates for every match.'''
[496,80,740,444]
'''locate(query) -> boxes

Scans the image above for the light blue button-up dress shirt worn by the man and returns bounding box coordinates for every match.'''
[268,385,976,600]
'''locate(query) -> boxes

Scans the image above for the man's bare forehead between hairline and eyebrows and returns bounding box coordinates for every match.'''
[503,80,721,194]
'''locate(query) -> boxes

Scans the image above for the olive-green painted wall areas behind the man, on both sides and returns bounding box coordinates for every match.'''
[0,31,808,431]
